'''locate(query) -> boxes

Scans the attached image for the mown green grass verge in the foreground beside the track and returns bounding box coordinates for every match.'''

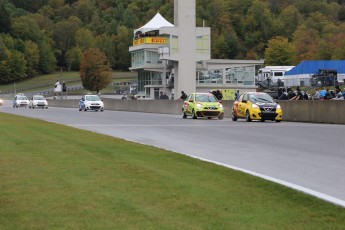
[0,113,345,230]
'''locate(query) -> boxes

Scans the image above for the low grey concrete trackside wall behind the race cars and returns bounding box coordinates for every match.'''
[48,98,345,124]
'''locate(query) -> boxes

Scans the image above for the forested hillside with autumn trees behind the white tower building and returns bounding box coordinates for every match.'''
[0,0,345,84]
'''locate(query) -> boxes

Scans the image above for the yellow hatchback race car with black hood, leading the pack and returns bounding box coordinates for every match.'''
[231,92,283,122]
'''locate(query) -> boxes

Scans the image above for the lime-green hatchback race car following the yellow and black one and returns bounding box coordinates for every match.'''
[182,93,224,119]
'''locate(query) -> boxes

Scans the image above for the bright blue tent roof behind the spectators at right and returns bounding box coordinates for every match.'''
[285,60,345,75]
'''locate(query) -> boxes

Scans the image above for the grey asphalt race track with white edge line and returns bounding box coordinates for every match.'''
[0,101,345,207]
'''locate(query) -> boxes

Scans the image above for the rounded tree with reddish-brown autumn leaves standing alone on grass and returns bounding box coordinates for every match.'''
[80,48,111,94]
